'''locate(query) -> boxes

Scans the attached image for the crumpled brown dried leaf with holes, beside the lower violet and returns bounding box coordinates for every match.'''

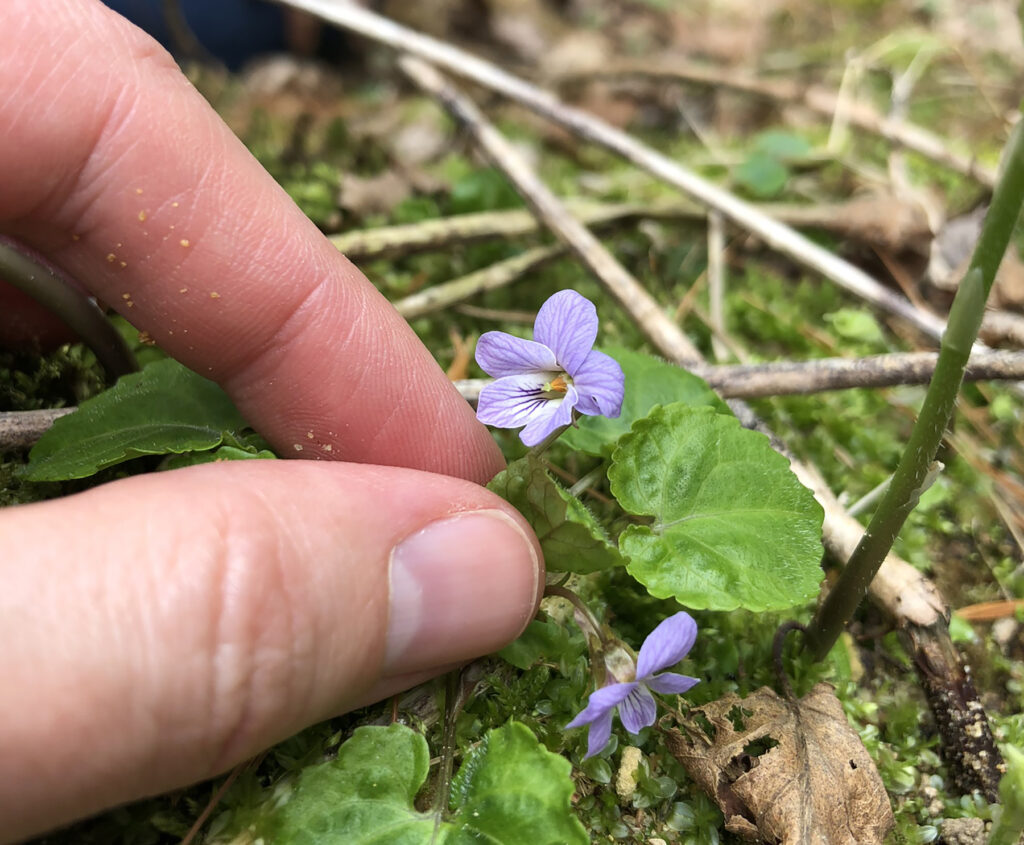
[667,683,894,845]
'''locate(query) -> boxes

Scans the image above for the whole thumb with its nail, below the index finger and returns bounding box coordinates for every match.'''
[0,461,543,839]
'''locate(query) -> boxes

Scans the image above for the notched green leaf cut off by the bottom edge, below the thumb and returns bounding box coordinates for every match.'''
[260,722,588,845]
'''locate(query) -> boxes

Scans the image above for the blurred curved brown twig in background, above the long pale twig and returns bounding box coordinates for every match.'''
[563,60,995,187]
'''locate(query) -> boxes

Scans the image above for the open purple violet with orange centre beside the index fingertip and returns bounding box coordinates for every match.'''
[476,291,625,446]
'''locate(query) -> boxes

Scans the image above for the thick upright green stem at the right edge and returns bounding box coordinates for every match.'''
[807,126,1024,660]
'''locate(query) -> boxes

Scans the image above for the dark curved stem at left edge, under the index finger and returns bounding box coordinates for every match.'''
[0,237,138,380]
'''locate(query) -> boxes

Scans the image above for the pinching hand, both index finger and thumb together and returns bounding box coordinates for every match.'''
[0,0,544,840]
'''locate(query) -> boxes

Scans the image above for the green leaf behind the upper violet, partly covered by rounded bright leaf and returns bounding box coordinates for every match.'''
[561,347,732,458]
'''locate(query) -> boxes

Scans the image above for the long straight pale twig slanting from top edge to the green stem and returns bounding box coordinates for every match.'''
[278,0,945,346]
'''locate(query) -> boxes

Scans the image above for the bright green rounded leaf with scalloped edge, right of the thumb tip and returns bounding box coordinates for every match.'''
[608,405,822,610]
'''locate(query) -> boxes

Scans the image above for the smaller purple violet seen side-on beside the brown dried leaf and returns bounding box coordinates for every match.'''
[565,611,699,760]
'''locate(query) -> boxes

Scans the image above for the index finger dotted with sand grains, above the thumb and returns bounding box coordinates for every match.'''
[0,0,502,482]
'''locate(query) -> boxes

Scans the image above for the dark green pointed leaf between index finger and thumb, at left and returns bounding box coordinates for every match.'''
[24,358,246,481]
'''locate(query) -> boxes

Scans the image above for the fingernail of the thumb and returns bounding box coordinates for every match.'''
[384,510,541,676]
